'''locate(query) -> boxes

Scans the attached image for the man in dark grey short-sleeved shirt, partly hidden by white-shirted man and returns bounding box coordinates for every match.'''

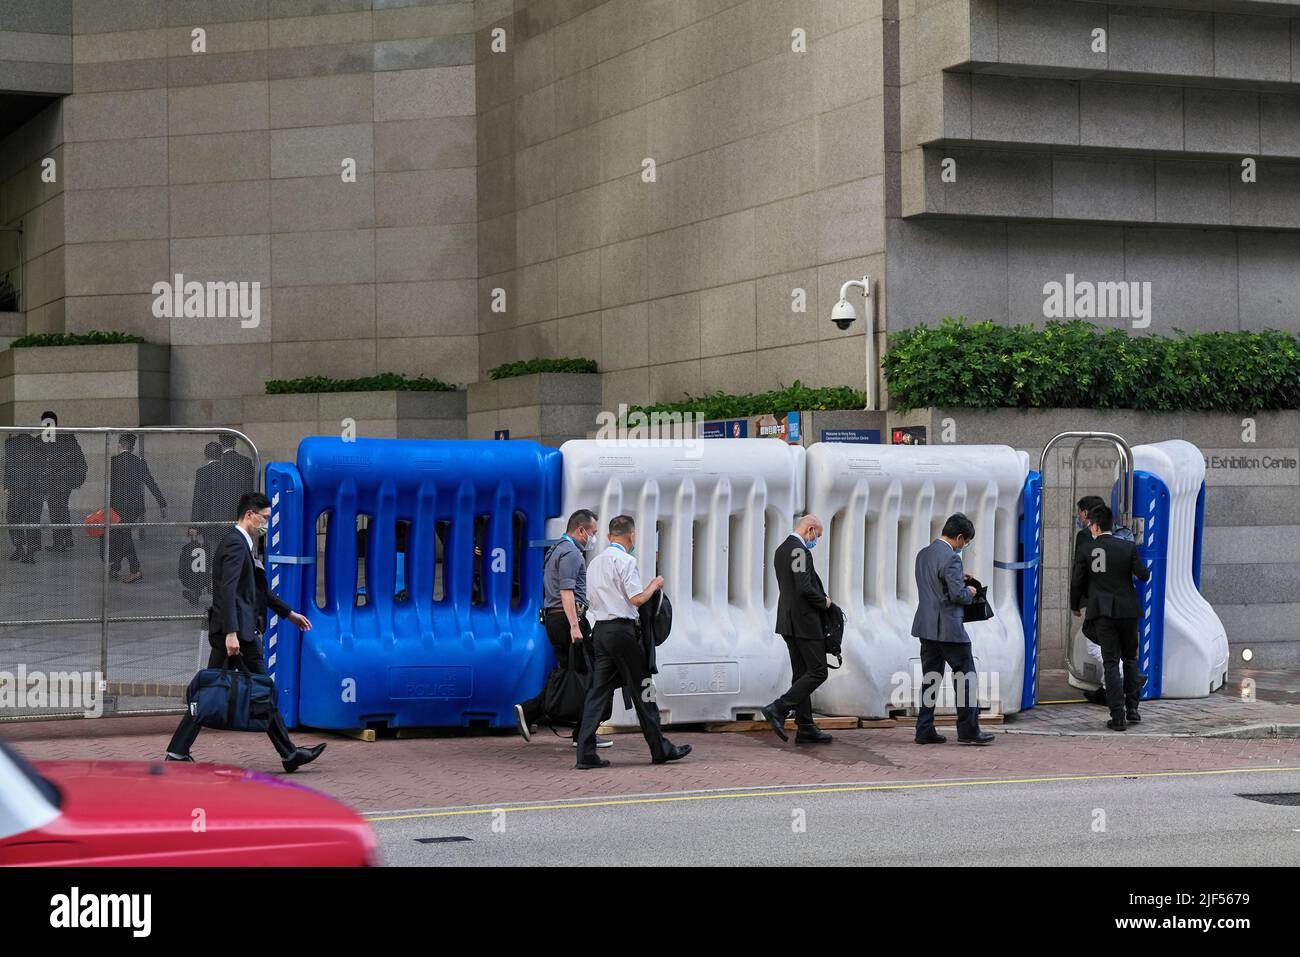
[515,508,614,748]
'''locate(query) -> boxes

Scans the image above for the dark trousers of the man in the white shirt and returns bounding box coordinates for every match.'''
[577,618,671,765]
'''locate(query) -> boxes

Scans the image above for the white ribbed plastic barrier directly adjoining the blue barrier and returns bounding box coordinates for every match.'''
[549,438,805,727]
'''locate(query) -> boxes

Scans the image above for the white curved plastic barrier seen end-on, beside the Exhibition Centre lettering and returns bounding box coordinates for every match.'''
[1134,439,1227,698]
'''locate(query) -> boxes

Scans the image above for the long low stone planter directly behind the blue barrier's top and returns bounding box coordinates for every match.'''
[242,390,465,463]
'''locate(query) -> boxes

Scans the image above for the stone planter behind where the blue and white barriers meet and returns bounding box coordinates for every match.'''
[467,372,602,446]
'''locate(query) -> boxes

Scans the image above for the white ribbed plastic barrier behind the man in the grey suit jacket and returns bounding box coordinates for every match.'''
[807,442,1030,716]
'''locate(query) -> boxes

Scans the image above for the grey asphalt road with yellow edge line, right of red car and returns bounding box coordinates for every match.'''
[367,770,1300,866]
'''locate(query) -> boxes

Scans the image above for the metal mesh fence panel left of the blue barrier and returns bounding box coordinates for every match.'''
[0,428,261,720]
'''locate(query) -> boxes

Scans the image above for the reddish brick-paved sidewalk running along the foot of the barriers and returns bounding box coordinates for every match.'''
[0,716,1300,811]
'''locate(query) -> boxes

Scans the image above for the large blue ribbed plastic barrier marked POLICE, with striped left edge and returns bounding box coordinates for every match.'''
[267,437,560,728]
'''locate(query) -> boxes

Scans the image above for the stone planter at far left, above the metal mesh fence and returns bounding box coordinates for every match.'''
[0,342,170,426]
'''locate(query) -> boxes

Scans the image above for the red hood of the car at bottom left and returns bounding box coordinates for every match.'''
[0,761,376,867]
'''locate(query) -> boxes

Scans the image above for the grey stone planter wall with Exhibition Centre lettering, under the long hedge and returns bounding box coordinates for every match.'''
[888,408,1300,668]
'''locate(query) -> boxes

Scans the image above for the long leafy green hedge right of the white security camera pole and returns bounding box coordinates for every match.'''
[881,316,1300,412]
